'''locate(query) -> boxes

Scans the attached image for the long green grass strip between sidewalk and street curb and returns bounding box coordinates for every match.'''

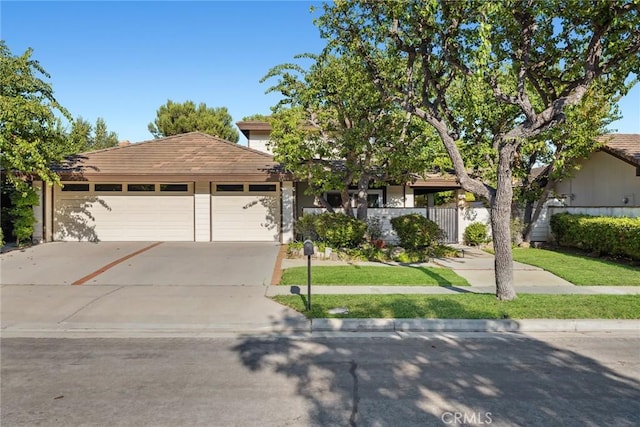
[273,293,640,319]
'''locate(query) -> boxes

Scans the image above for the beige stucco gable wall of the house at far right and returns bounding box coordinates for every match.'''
[556,151,640,206]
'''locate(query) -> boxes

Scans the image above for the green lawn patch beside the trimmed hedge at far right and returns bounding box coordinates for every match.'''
[513,248,640,286]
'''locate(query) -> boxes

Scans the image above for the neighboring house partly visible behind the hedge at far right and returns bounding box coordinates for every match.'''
[531,134,640,242]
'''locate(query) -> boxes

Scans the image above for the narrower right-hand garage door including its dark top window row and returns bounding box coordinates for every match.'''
[211,183,280,242]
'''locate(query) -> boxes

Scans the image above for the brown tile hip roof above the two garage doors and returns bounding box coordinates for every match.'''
[57,132,288,180]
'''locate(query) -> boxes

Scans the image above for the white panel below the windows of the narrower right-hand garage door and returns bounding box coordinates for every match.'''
[211,193,280,242]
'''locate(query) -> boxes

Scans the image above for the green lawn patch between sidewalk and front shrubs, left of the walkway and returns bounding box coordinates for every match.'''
[280,265,469,286]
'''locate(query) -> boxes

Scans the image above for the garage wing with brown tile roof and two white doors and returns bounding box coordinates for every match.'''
[34,132,293,242]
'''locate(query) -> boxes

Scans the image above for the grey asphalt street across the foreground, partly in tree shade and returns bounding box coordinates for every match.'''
[0,332,640,427]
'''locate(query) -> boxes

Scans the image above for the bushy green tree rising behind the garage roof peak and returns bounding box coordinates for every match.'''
[149,100,239,142]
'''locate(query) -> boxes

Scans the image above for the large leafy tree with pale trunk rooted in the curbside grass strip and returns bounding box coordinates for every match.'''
[318,0,640,300]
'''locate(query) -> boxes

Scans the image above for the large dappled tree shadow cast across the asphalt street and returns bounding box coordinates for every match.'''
[233,302,640,426]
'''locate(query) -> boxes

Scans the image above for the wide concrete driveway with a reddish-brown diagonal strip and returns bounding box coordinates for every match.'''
[0,242,309,337]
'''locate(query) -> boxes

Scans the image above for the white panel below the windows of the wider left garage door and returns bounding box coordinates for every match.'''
[54,195,194,241]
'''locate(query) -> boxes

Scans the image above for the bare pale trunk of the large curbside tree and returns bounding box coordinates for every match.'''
[491,142,516,301]
